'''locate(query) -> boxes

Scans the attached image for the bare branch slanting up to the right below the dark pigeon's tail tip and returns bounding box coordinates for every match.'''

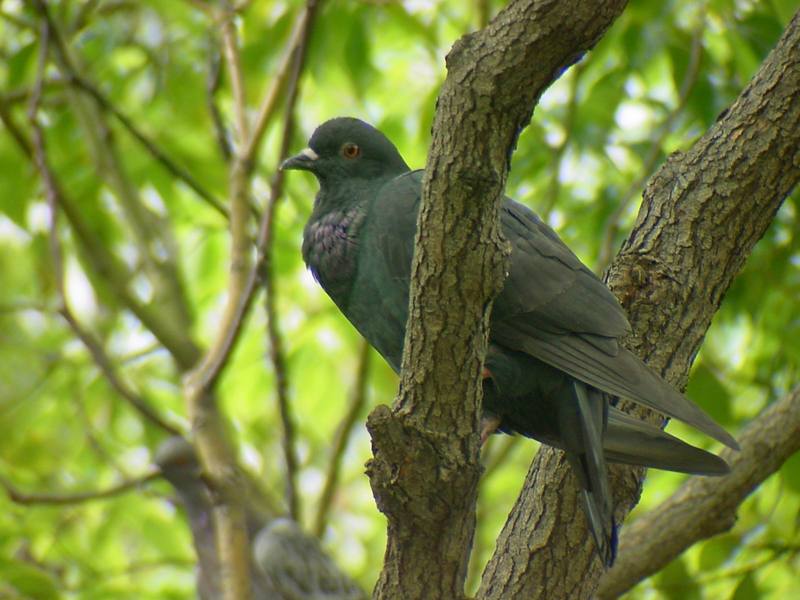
[598,387,800,599]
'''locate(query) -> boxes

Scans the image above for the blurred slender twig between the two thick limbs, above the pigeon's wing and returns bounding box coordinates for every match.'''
[596,15,706,273]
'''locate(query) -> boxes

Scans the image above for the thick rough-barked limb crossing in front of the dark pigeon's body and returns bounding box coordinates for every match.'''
[368,0,625,599]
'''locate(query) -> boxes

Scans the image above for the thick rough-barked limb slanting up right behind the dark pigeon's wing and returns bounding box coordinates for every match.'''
[479,13,800,599]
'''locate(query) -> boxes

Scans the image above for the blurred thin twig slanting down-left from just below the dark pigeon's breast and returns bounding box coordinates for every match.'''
[312,341,370,537]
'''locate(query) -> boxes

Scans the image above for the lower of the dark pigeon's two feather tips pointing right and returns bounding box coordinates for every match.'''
[603,406,730,475]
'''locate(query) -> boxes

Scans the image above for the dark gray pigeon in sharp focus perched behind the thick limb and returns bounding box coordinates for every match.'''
[282,117,738,565]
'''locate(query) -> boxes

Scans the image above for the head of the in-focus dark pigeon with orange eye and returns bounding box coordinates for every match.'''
[281,117,409,186]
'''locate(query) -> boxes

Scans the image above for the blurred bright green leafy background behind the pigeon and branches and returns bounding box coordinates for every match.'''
[0,0,800,599]
